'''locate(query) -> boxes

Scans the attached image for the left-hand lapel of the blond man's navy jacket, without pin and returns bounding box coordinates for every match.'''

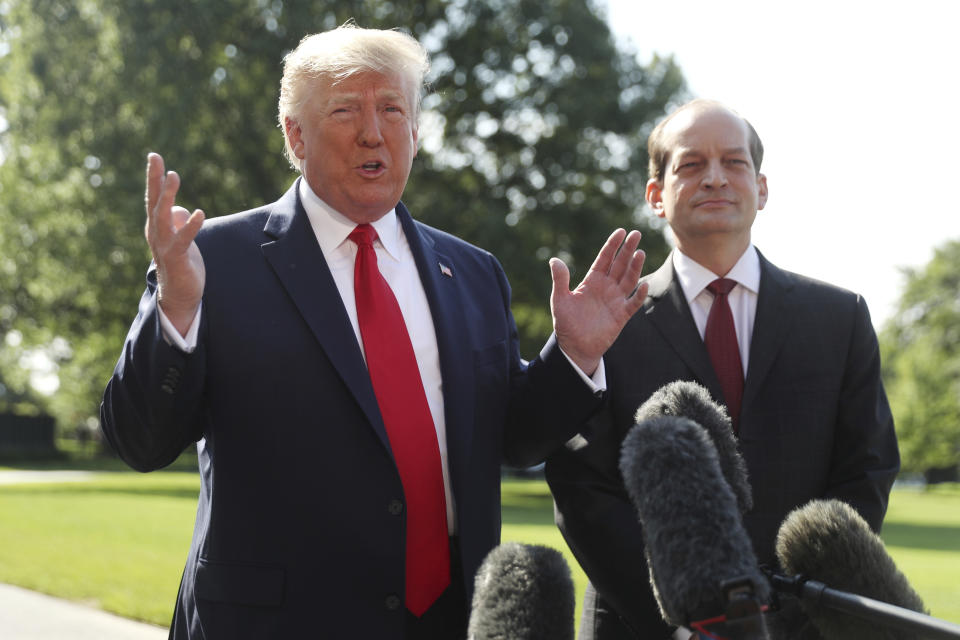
[261,183,390,450]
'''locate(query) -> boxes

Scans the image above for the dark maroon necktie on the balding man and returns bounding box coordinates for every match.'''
[703,278,743,431]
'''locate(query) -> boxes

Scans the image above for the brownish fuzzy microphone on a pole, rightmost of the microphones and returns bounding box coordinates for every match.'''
[773,500,960,640]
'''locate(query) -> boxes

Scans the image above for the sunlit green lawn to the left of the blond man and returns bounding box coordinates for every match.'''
[0,473,199,625]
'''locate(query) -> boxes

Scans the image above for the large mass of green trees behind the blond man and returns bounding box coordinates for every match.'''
[0,0,684,427]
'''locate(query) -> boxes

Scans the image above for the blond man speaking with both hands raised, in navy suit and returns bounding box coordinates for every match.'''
[101,25,645,640]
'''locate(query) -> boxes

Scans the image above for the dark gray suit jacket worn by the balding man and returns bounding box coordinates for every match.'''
[546,255,900,640]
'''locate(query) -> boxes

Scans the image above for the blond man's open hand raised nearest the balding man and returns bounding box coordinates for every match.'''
[550,229,648,375]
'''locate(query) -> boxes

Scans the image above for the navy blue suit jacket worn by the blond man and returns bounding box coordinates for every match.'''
[101,184,599,640]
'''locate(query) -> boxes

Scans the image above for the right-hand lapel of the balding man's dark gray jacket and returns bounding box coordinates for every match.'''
[743,251,800,408]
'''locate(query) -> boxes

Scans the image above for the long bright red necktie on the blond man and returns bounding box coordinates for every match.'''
[349,224,450,616]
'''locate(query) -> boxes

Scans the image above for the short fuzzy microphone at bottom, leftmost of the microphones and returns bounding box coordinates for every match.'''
[467,542,576,640]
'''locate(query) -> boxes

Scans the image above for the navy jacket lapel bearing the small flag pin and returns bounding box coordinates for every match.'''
[397,202,476,466]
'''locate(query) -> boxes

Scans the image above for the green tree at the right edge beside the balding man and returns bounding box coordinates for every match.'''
[881,240,960,471]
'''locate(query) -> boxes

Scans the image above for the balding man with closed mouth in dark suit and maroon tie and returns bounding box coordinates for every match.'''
[546,100,899,640]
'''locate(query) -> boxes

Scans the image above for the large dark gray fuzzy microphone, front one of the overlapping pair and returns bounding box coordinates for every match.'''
[620,416,770,639]
